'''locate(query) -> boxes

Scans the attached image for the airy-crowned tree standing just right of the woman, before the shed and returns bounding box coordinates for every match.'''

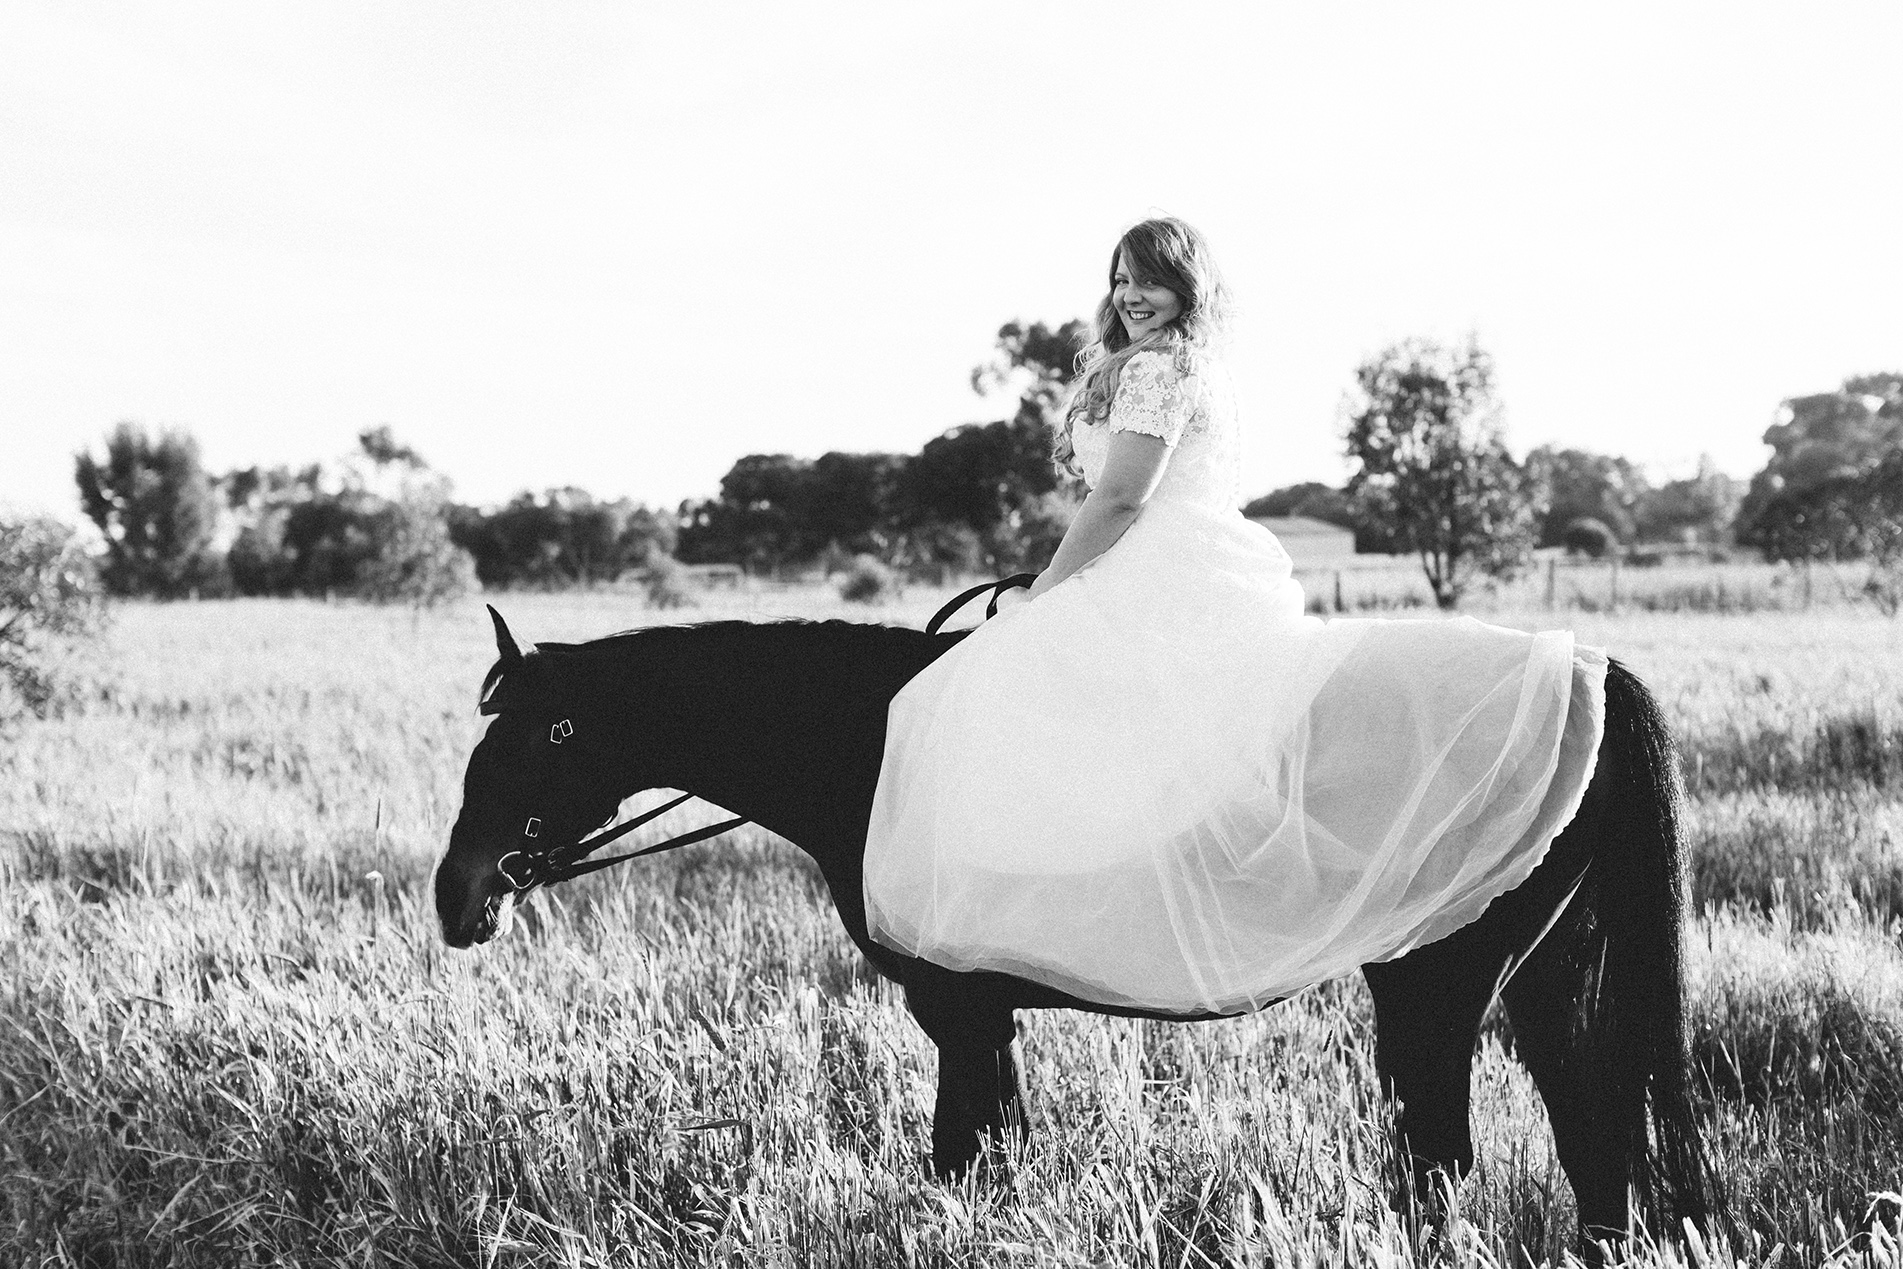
[1347,339,1540,609]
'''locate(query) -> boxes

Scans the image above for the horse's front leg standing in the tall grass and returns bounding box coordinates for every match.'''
[906,961,1030,1180]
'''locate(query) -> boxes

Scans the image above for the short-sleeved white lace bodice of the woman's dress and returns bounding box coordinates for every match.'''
[1071,352,1243,510]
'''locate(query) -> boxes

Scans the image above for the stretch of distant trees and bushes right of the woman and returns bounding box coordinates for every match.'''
[1245,348,1903,607]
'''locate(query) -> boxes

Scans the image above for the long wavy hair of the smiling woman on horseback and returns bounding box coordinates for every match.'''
[1052,217,1229,472]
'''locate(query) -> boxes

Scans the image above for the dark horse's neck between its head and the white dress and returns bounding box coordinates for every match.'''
[597,624,931,864]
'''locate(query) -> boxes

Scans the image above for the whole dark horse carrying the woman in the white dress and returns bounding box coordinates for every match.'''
[436,609,1707,1239]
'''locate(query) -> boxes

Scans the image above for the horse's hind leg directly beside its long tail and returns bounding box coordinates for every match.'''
[1501,909,1646,1248]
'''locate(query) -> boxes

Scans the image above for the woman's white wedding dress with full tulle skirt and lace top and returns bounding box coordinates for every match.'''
[866,352,1606,1012]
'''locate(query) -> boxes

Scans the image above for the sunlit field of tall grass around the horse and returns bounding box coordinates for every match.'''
[0,592,1903,1265]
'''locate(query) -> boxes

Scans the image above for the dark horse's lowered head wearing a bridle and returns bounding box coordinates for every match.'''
[436,609,620,947]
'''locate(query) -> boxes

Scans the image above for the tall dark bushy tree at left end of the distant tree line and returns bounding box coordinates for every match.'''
[72,422,217,597]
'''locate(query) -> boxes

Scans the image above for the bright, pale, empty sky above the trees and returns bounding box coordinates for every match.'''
[0,0,1903,519]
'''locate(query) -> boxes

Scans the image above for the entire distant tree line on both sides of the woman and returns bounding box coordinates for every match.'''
[40,322,1903,607]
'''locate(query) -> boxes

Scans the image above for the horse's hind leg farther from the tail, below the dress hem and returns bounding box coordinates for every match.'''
[1361,943,1505,1204]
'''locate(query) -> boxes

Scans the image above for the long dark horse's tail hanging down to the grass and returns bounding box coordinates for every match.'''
[1587,660,1717,1237]
